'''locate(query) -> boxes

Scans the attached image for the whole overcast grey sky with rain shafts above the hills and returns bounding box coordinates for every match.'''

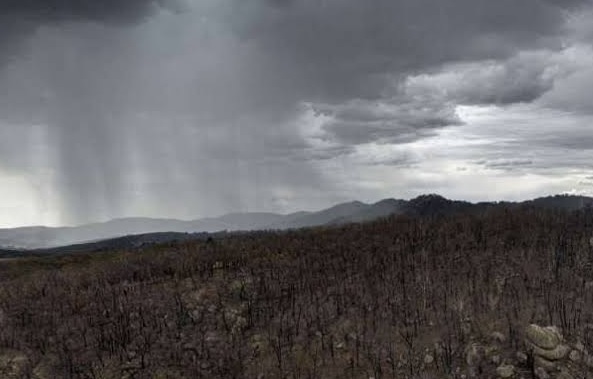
[0,0,593,227]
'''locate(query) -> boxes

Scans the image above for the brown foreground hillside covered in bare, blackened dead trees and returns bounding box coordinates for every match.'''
[0,208,593,379]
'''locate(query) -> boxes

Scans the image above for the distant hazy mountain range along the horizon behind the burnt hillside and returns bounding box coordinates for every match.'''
[0,195,593,253]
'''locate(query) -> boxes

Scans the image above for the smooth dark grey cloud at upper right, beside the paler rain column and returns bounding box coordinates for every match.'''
[237,0,585,101]
